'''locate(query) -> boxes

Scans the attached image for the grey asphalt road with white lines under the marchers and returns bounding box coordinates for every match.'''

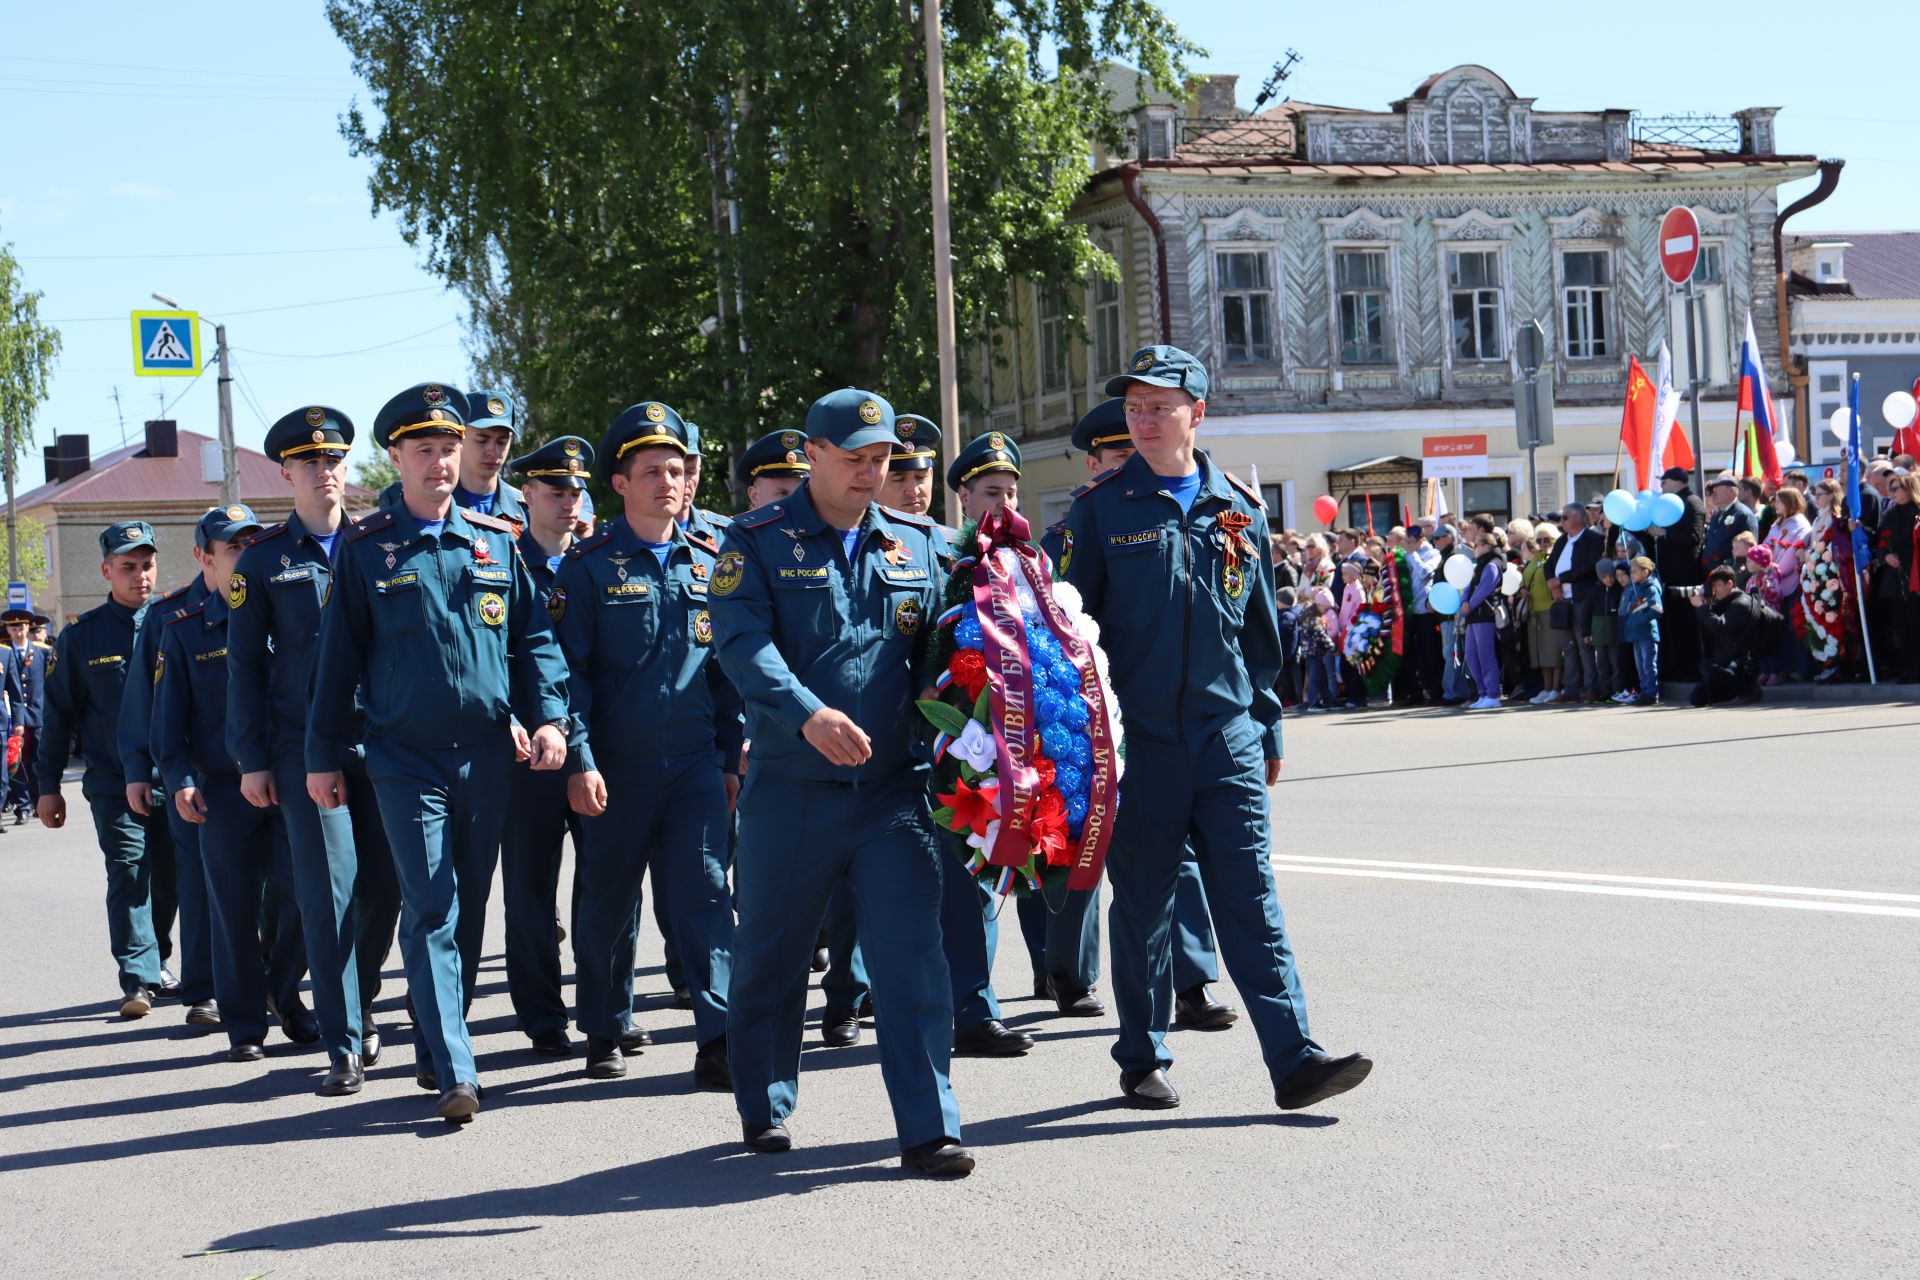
[0,704,1920,1280]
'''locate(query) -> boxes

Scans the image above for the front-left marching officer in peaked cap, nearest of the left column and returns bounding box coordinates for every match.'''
[307,382,570,1123]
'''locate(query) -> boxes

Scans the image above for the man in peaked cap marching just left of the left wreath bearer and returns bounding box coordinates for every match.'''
[555,401,743,1088]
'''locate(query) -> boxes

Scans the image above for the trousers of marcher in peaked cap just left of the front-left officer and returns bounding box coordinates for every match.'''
[273,743,399,1055]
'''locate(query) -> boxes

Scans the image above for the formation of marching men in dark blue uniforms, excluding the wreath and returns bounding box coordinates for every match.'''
[22,347,1371,1176]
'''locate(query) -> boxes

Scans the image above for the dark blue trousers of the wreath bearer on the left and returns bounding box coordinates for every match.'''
[728,768,960,1148]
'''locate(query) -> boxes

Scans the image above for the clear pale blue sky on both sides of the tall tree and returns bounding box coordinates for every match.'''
[0,0,1920,468]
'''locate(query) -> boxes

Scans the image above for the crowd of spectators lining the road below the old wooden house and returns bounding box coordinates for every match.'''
[1273,455,1920,714]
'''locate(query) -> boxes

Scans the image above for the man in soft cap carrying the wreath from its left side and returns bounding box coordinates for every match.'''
[710,388,973,1174]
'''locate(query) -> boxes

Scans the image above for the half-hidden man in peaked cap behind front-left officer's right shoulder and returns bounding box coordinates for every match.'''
[499,436,593,1057]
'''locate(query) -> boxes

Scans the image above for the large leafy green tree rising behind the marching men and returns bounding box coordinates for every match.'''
[328,0,1196,491]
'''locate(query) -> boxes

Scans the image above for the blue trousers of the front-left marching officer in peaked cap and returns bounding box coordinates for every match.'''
[367,725,513,1090]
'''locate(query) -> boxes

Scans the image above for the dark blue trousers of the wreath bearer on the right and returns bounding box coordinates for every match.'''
[1106,716,1319,1082]
